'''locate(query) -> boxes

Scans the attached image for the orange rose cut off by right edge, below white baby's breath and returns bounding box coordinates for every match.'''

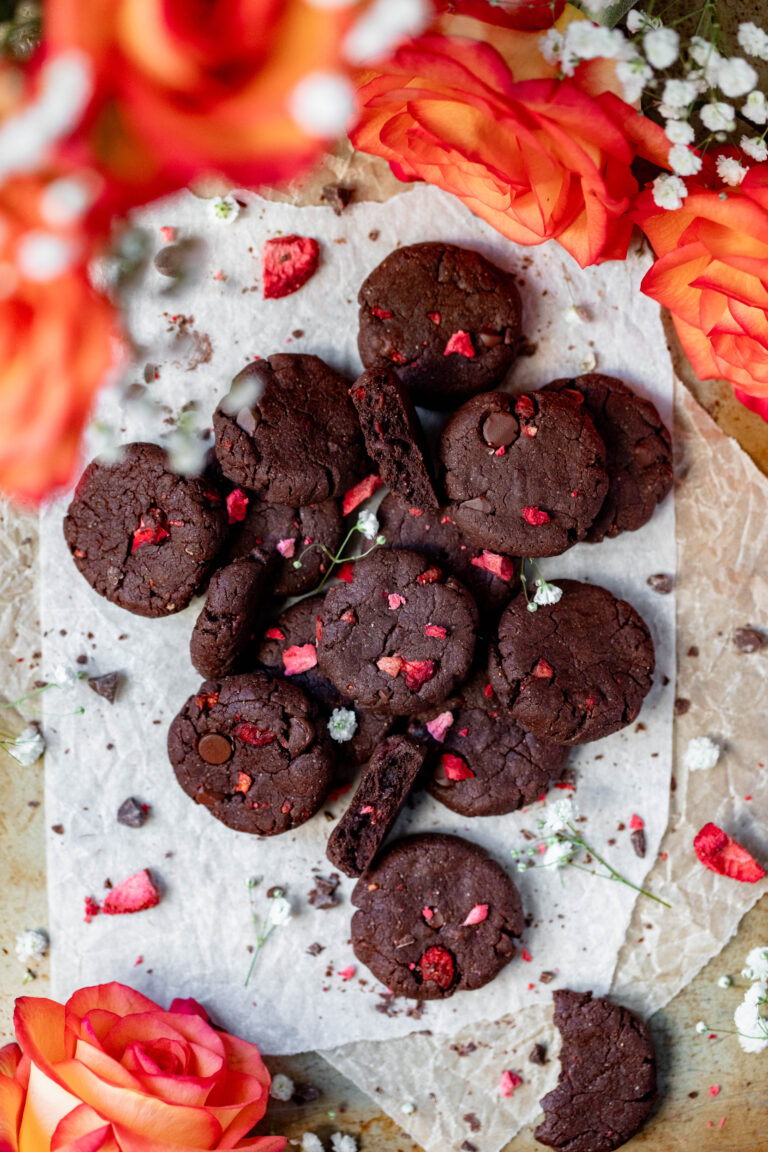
[634,164,768,405]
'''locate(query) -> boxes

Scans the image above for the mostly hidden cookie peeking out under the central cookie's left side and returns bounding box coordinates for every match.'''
[257,596,393,779]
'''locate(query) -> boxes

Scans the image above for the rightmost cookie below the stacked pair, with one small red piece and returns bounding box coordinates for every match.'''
[488,579,655,744]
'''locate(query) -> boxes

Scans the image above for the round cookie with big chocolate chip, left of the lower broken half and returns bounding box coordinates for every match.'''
[168,672,334,836]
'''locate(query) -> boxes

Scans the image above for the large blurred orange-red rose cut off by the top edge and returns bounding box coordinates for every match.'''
[45,0,364,216]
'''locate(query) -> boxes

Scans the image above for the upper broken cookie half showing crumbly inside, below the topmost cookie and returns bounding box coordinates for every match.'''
[349,365,440,508]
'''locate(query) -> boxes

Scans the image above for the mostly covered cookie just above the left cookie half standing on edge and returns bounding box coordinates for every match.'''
[227,492,342,596]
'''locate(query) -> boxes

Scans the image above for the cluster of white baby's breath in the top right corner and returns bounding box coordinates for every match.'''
[540,11,768,211]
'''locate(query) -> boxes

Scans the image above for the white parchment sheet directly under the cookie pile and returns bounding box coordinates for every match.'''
[41,188,675,1055]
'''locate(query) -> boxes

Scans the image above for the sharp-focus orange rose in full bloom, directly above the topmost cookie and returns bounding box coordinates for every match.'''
[350,9,669,267]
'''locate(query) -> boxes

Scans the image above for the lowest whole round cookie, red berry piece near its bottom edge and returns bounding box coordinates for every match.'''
[352,833,523,1000]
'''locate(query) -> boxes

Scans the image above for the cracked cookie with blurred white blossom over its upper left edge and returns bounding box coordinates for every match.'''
[213,353,365,505]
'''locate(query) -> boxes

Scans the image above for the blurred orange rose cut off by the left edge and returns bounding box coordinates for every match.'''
[0,168,116,500]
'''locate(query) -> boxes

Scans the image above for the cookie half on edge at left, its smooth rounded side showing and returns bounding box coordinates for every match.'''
[189,553,269,680]
